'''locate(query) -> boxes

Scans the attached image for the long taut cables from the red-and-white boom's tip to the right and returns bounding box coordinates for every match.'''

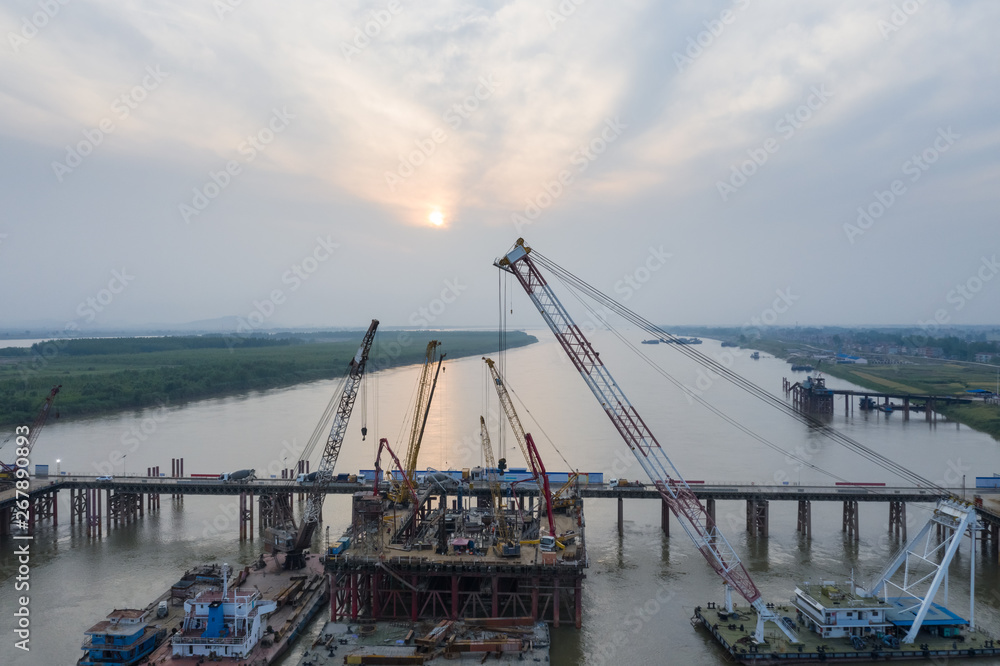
[532,251,947,492]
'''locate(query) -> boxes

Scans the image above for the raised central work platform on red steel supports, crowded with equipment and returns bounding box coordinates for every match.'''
[326,489,587,627]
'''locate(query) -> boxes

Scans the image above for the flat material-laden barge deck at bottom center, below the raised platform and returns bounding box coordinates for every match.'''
[299,618,549,666]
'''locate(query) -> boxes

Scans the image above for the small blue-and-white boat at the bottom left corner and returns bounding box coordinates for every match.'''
[76,608,167,666]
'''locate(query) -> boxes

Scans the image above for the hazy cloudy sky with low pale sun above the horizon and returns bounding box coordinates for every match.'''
[0,0,1000,332]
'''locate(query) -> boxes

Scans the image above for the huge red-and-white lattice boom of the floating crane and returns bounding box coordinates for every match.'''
[494,238,798,642]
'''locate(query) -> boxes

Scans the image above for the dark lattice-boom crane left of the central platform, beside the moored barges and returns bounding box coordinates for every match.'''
[265,319,378,569]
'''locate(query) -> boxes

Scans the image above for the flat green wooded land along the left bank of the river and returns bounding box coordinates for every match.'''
[0,331,537,425]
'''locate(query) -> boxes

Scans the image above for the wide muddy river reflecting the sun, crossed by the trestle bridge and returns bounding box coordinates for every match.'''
[0,331,1000,666]
